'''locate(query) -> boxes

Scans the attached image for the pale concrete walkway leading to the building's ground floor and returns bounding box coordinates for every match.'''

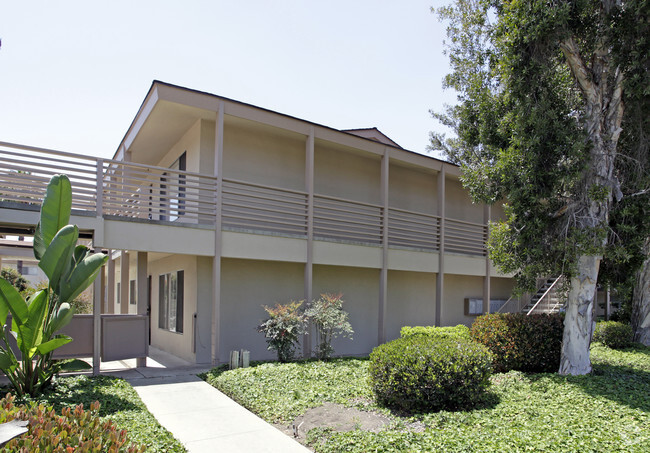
[101,348,310,453]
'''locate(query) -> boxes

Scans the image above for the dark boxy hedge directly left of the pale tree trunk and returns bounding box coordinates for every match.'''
[470,313,564,372]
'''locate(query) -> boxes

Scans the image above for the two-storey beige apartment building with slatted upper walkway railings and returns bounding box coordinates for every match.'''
[0,81,513,363]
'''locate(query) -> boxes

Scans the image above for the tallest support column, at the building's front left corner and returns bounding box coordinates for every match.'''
[212,101,224,365]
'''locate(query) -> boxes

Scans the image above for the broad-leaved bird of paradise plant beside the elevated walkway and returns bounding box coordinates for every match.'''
[0,175,108,396]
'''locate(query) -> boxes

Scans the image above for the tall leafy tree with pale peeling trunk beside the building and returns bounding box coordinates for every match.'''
[431,0,648,374]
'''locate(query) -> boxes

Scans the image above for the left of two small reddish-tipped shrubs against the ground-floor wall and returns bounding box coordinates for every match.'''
[257,301,305,362]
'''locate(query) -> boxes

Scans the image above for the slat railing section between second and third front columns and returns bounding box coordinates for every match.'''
[314,195,383,245]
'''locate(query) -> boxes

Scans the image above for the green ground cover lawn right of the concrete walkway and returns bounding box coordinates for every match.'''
[205,345,650,452]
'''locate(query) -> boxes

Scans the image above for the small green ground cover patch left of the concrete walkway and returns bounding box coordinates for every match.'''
[6,376,186,452]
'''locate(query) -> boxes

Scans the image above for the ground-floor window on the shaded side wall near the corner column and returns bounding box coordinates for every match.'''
[158,271,185,333]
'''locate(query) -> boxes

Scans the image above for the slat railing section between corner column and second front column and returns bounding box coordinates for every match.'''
[222,179,307,237]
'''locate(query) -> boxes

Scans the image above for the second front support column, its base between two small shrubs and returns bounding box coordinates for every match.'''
[302,126,314,357]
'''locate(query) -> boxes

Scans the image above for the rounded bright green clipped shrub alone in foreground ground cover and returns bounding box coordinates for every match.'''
[368,335,492,411]
